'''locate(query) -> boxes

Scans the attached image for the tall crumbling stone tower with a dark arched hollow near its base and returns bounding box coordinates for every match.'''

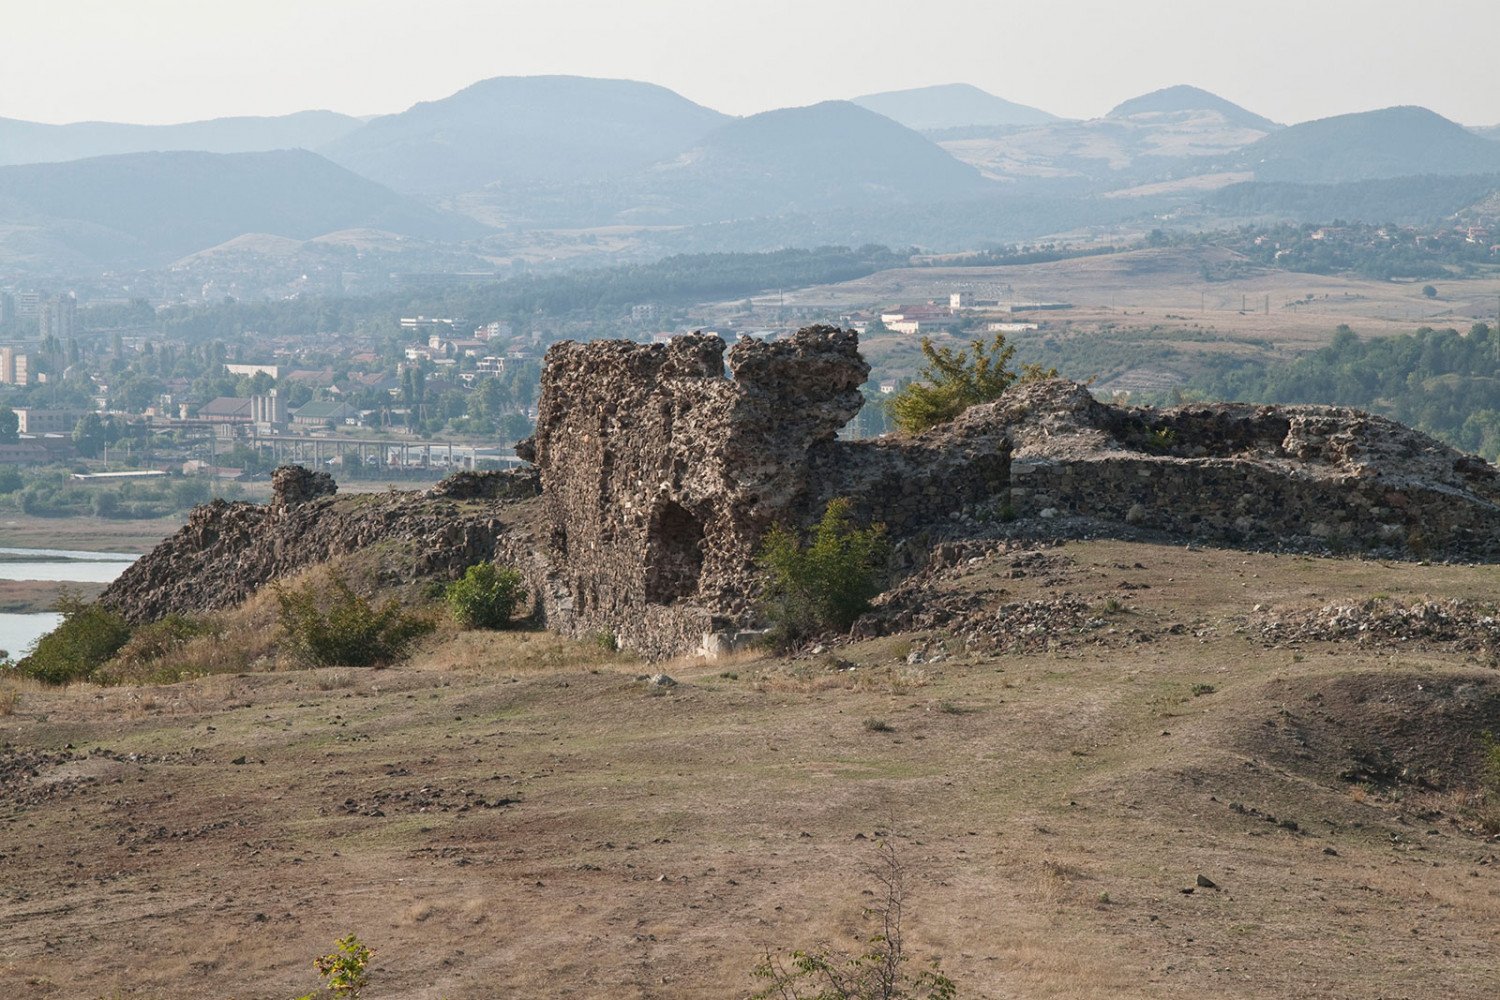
[533,327,870,652]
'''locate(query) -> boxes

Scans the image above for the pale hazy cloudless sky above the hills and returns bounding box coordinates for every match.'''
[11,0,1500,124]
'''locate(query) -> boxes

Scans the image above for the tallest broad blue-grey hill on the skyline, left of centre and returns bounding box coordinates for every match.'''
[320,76,729,196]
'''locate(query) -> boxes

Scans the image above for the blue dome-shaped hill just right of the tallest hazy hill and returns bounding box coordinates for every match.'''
[629,100,990,222]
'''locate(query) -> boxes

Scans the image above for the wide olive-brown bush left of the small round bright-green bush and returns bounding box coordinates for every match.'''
[275,573,435,667]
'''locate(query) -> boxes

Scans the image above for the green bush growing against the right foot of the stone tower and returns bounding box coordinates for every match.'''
[758,496,890,646]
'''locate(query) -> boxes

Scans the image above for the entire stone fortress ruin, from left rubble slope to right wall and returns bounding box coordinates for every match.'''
[101,327,1500,657]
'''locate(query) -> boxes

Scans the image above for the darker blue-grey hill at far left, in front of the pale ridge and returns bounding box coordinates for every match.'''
[0,150,485,264]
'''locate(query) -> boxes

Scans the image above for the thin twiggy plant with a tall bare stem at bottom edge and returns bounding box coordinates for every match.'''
[750,841,959,1000]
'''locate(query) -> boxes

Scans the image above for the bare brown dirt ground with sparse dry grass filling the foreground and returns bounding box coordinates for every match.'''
[0,543,1500,1000]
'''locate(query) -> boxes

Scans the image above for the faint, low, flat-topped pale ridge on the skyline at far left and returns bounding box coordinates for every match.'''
[0,111,362,166]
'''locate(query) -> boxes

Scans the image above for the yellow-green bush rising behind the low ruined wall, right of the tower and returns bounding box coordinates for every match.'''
[890,333,1058,433]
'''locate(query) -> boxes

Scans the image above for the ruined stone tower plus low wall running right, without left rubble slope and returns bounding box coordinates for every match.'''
[534,335,1500,655]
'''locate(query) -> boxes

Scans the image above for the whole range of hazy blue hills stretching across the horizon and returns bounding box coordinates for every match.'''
[0,76,1500,277]
